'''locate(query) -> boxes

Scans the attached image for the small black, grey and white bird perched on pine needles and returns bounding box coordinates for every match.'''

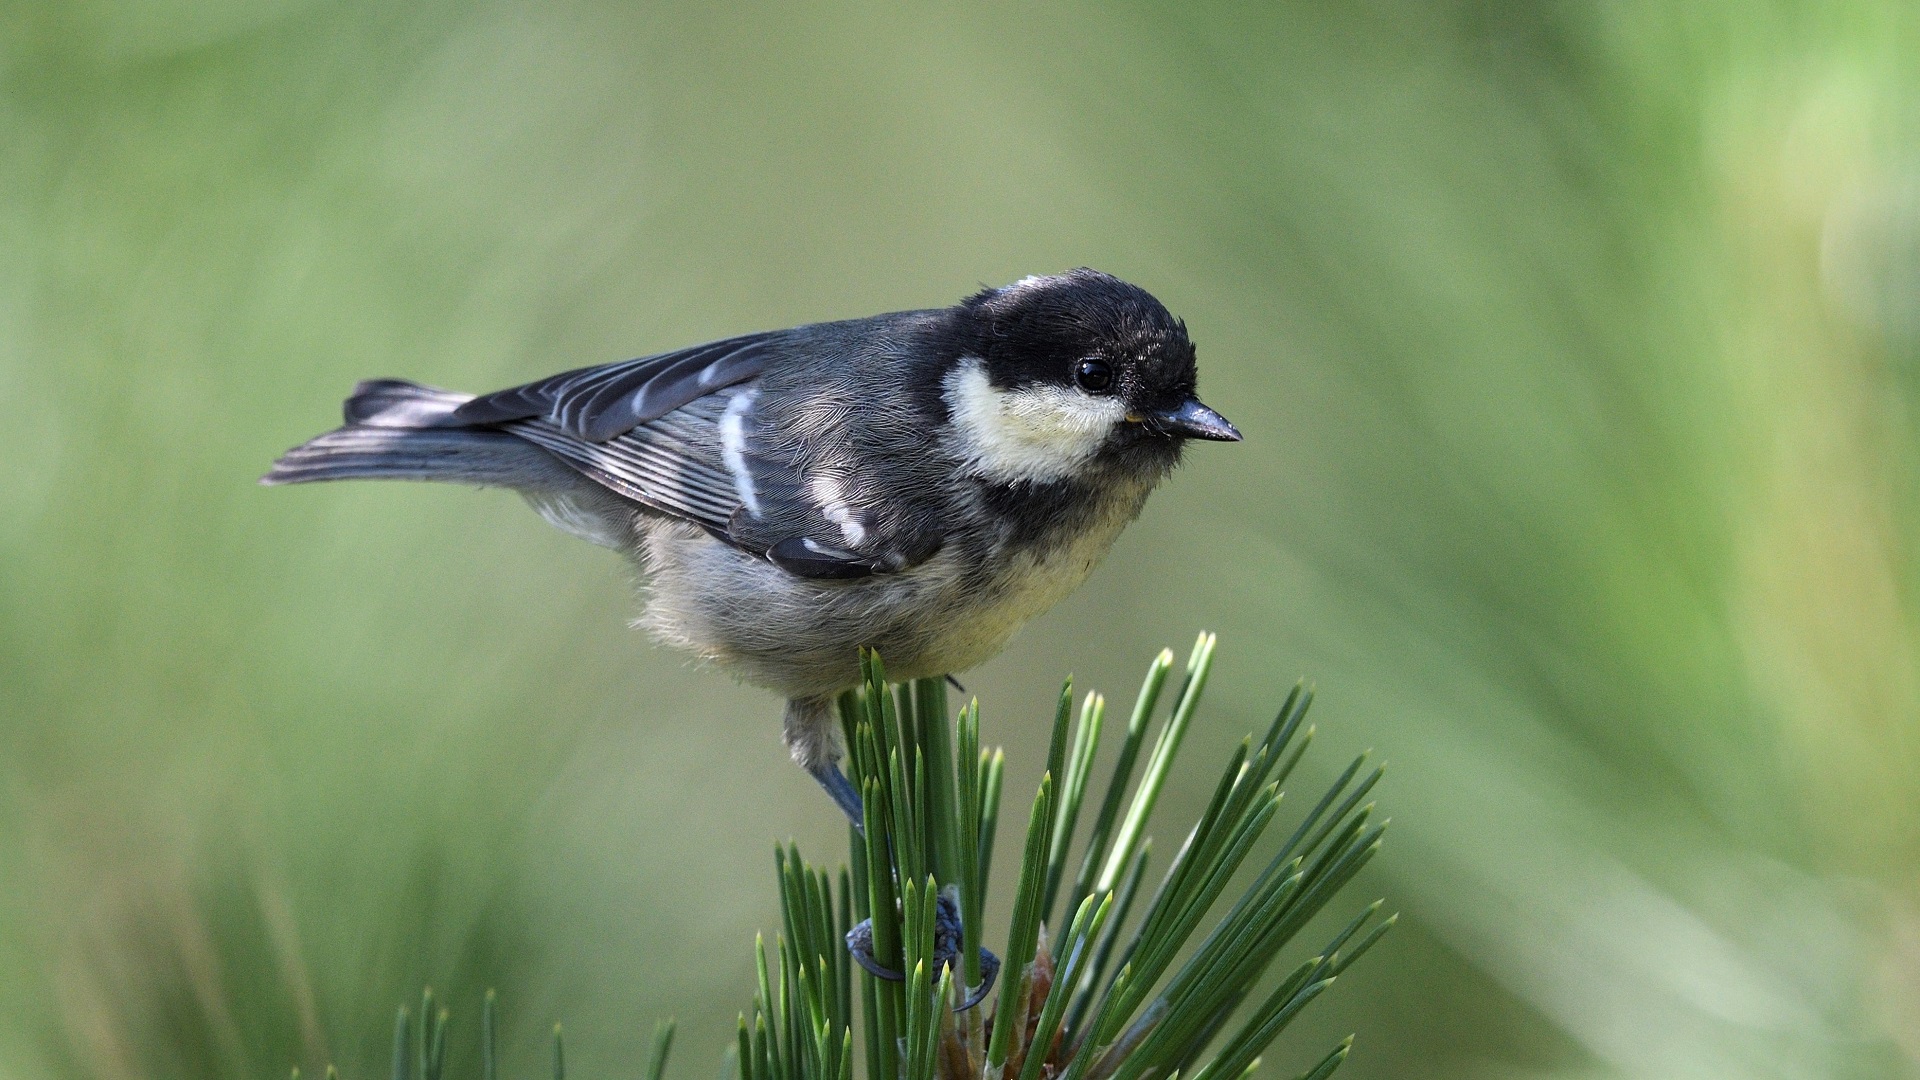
[261,269,1240,822]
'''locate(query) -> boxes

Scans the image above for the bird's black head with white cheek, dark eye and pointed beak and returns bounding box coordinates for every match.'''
[941,267,1240,482]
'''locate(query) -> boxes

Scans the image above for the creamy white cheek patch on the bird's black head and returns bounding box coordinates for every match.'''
[941,356,1127,484]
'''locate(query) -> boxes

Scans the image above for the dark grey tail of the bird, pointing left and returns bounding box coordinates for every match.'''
[259,379,553,486]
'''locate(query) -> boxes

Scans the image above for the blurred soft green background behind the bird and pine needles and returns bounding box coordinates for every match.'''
[0,0,1920,1080]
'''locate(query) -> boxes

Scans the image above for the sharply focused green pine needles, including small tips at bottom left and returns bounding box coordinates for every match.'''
[349,634,1398,1080]
